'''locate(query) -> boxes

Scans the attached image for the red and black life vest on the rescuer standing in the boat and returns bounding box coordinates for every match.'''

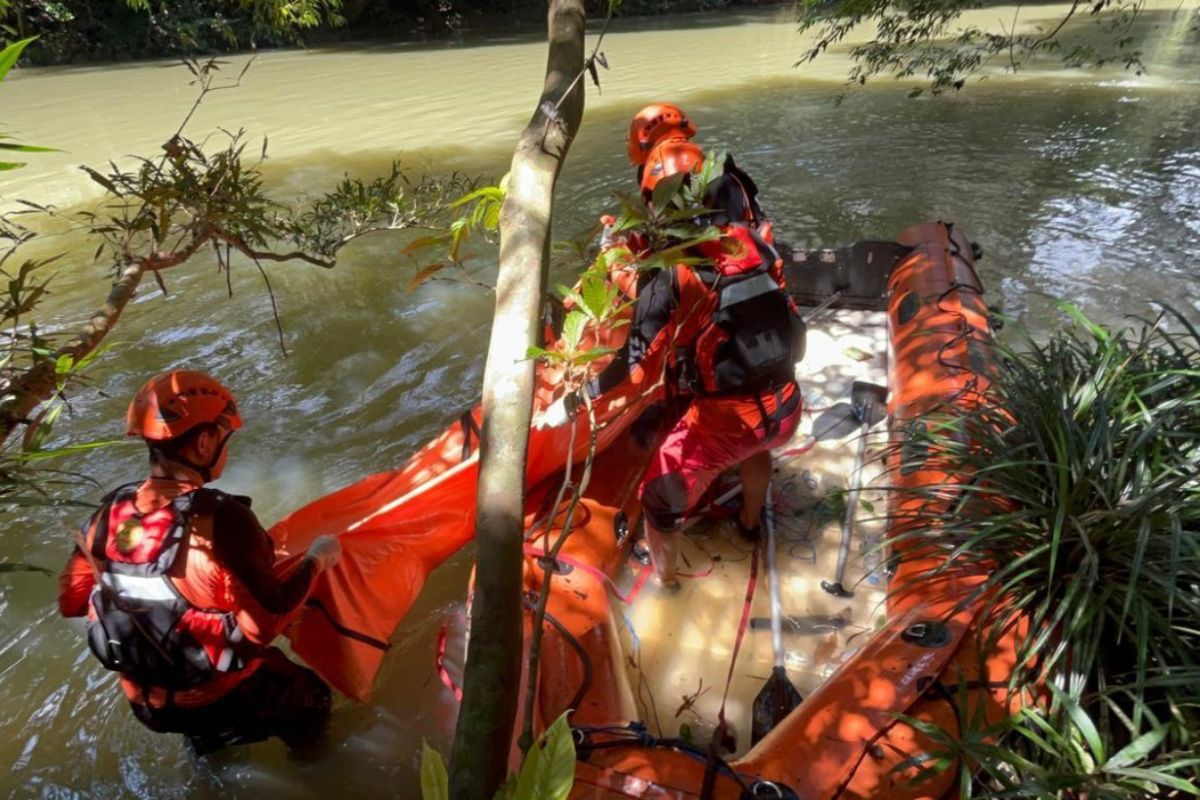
[678,223,805,395]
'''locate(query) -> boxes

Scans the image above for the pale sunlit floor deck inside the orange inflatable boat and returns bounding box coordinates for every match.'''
[614,311,888,753]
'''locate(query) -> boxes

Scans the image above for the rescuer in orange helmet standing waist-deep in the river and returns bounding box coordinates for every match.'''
[59,371,341,753]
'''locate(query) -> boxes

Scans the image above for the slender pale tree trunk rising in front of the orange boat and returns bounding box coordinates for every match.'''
[450,0,584,800]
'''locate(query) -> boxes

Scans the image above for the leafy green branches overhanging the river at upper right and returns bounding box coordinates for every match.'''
[797,0,1142,97]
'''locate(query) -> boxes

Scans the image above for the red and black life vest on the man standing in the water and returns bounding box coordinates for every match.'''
[88,485,246,690]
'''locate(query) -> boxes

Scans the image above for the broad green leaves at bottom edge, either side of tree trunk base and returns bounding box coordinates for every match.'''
[421,714,575,800]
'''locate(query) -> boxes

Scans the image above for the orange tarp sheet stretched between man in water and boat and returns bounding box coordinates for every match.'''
[270,326,661,700]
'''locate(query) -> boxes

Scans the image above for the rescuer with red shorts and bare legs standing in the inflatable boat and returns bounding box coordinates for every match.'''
[540,136,804,588]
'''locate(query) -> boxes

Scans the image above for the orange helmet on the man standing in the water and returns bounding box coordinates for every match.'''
[125,369,241,441]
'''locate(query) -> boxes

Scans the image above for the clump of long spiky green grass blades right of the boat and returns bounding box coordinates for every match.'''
[904,306,1200,800]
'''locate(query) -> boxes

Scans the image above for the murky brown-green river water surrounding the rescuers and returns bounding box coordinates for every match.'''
[0,2,1200,798]
